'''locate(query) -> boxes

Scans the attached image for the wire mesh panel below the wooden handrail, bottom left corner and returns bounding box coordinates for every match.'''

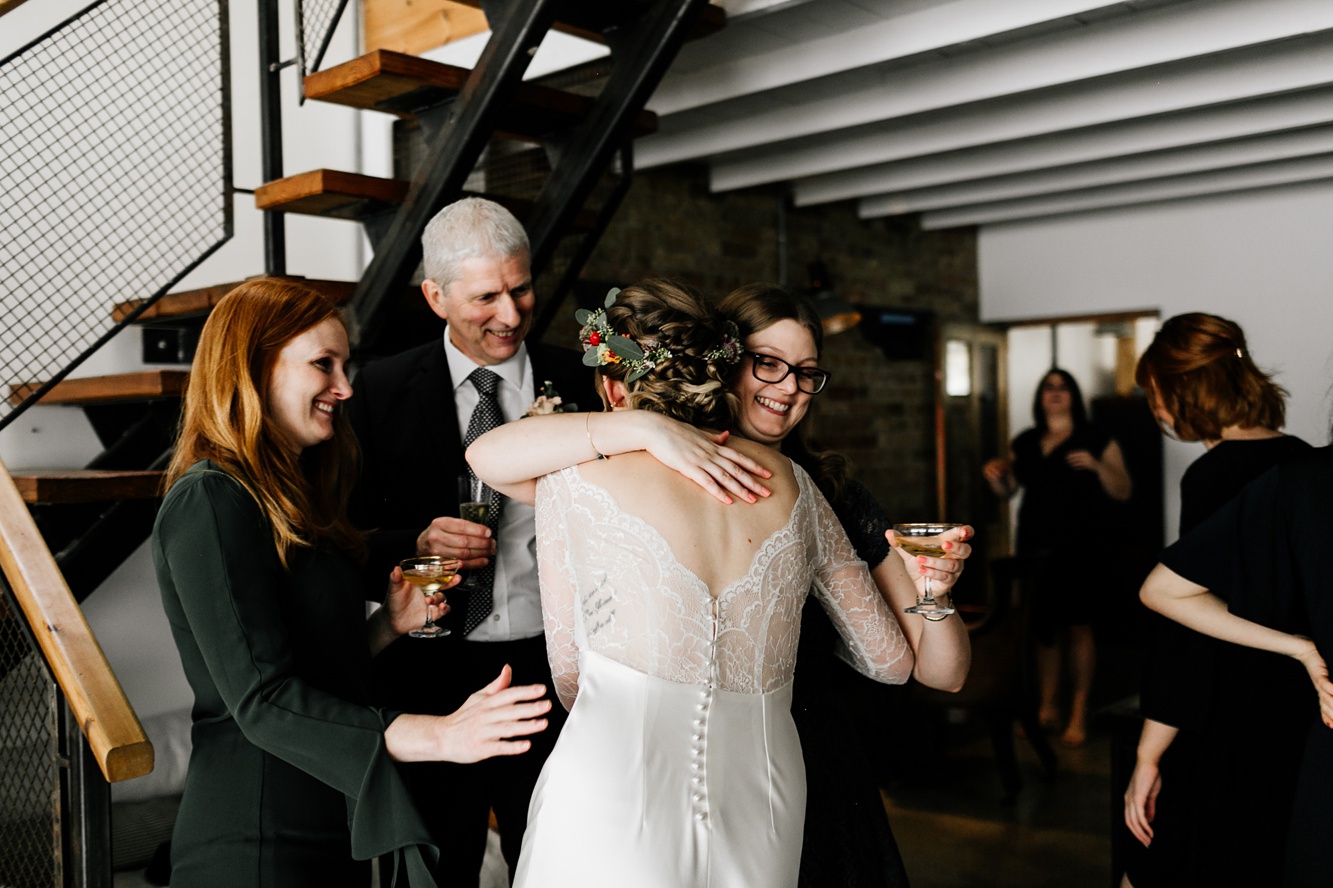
[0,580,63,888]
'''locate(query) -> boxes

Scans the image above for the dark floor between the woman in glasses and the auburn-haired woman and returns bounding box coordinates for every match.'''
[853,629,1142,888]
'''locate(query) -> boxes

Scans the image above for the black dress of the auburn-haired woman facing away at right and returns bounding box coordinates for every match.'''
[1126,436,1312,888]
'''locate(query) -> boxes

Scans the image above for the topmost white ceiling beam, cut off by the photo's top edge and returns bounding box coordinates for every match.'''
[648,0,1120,115]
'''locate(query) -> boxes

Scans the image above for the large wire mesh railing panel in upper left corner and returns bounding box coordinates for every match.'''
[0,0,232,427]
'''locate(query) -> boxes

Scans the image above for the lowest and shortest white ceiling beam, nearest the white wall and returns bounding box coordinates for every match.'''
[921,155,1333,229]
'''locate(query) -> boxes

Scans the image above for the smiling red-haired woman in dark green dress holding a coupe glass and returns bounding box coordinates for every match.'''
[152,280,551,888]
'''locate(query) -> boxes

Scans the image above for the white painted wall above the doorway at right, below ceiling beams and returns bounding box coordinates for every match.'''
[977,181,1333,539]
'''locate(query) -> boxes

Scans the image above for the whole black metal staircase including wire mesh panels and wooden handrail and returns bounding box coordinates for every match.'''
[0,0,724,885]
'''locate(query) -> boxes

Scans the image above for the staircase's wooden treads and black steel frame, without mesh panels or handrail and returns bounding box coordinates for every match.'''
[0,0,724,600]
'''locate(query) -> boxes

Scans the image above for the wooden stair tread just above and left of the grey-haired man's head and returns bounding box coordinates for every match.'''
[255,169,597,231]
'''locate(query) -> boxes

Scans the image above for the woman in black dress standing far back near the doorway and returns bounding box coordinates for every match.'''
[982,368,1130,747]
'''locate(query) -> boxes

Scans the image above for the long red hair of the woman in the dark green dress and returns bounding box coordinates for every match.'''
[165,277,365,567]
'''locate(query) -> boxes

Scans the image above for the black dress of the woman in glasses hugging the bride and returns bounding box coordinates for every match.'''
[792,481,908,888]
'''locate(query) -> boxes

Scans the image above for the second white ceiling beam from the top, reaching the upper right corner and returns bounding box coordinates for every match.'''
[636,0,1333,168]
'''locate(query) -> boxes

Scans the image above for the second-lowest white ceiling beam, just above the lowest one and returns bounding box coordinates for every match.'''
[857,125,1333,219]
